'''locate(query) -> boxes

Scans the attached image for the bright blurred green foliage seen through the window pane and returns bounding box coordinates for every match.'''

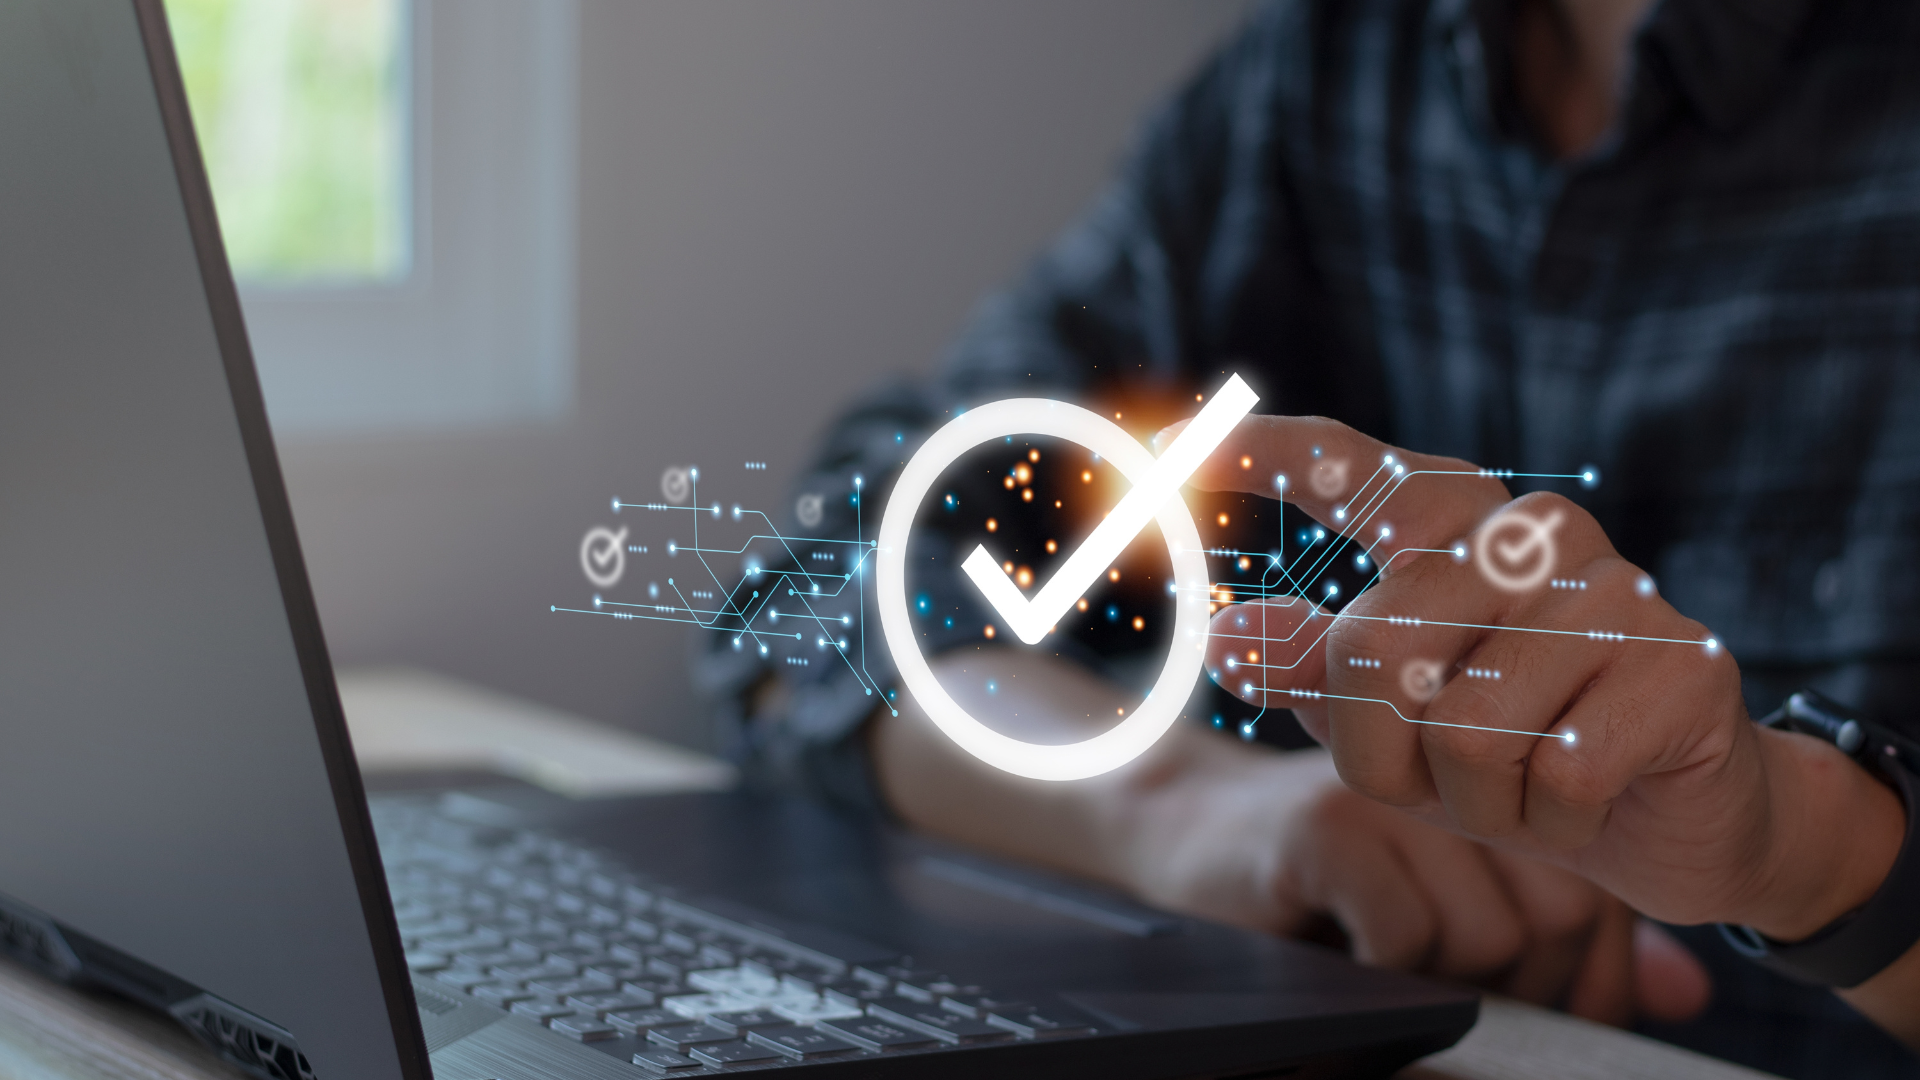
[165,0,409,282]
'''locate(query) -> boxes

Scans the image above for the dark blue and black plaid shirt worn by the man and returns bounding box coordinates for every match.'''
[708,0,1920,1076]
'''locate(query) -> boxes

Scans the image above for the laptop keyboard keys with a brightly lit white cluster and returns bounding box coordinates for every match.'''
[372,801,1098,1076]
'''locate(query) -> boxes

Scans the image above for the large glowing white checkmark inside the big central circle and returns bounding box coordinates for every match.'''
[960,375,1260,646]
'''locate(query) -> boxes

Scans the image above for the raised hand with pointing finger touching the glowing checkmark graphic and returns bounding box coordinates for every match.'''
[1167,417,1903,940]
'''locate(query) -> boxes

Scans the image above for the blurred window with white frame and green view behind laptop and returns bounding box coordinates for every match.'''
[167,0,578,434]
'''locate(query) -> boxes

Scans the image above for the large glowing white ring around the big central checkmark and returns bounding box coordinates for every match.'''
[874,398,1210,780]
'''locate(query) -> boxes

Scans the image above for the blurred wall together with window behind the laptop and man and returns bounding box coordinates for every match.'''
[167,0,1250,746]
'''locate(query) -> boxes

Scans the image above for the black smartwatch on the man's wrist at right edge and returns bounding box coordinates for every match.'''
[1720,690,1920,990]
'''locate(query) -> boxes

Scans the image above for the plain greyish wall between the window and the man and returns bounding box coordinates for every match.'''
[282,0,1246,744]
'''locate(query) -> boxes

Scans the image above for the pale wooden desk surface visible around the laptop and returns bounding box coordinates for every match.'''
[0,671,1764,1080]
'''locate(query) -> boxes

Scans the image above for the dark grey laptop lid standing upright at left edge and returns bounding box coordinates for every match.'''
[0,0,426,1080]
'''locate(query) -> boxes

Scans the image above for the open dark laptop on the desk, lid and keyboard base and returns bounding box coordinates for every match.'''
[0,0,1478,1080]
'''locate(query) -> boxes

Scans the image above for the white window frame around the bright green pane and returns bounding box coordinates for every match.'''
[240,0,580,436]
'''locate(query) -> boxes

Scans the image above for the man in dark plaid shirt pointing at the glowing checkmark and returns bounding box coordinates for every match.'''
[714,0,1920,1076]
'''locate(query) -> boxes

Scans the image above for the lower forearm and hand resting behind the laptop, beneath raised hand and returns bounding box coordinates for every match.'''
[874,648,1707,1022]
